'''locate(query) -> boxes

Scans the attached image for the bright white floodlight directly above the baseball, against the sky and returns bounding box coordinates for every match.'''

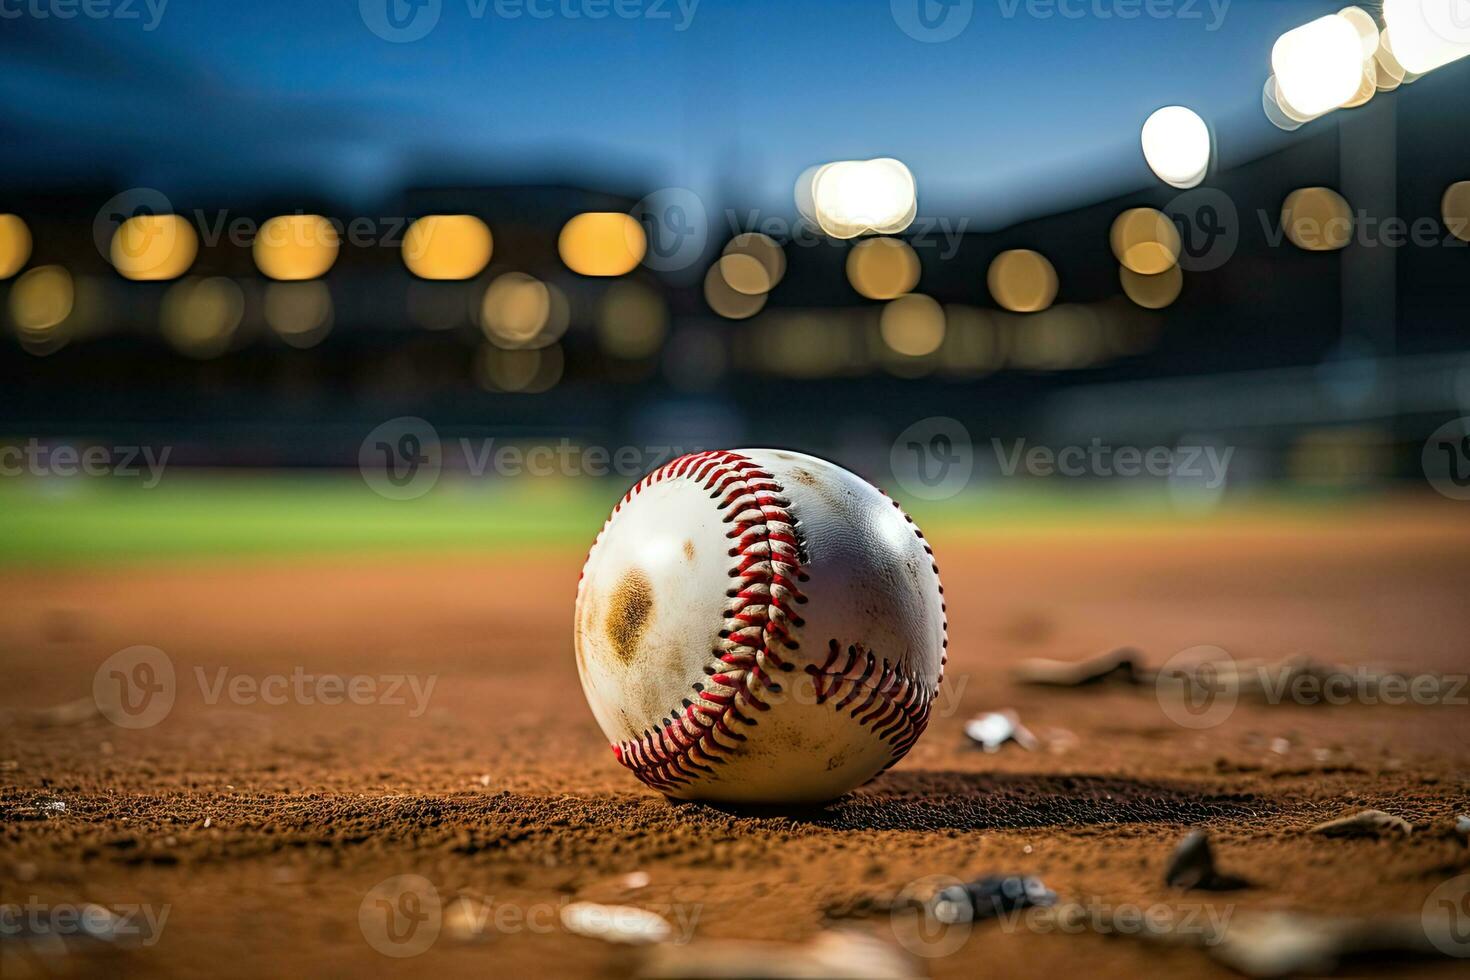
[797,157,919,238]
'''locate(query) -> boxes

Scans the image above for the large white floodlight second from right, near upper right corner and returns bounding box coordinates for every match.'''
[1272,13,1363,116]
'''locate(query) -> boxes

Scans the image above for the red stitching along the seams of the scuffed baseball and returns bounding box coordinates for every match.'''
[594,451,948,790]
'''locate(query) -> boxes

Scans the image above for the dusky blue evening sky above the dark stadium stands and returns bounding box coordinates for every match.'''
[0,0,1341,226]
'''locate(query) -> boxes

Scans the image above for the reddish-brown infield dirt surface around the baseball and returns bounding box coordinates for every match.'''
[0,504,1470,980]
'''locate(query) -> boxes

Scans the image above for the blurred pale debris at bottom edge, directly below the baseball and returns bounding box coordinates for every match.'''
[637,929,923,980]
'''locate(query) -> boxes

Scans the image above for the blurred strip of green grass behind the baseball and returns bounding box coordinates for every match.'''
[0,472,1375,564]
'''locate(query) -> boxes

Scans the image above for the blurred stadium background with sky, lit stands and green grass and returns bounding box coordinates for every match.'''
[0,0,1470,560]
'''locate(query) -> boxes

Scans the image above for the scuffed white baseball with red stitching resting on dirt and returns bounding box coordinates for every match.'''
[575,450,948,804]
